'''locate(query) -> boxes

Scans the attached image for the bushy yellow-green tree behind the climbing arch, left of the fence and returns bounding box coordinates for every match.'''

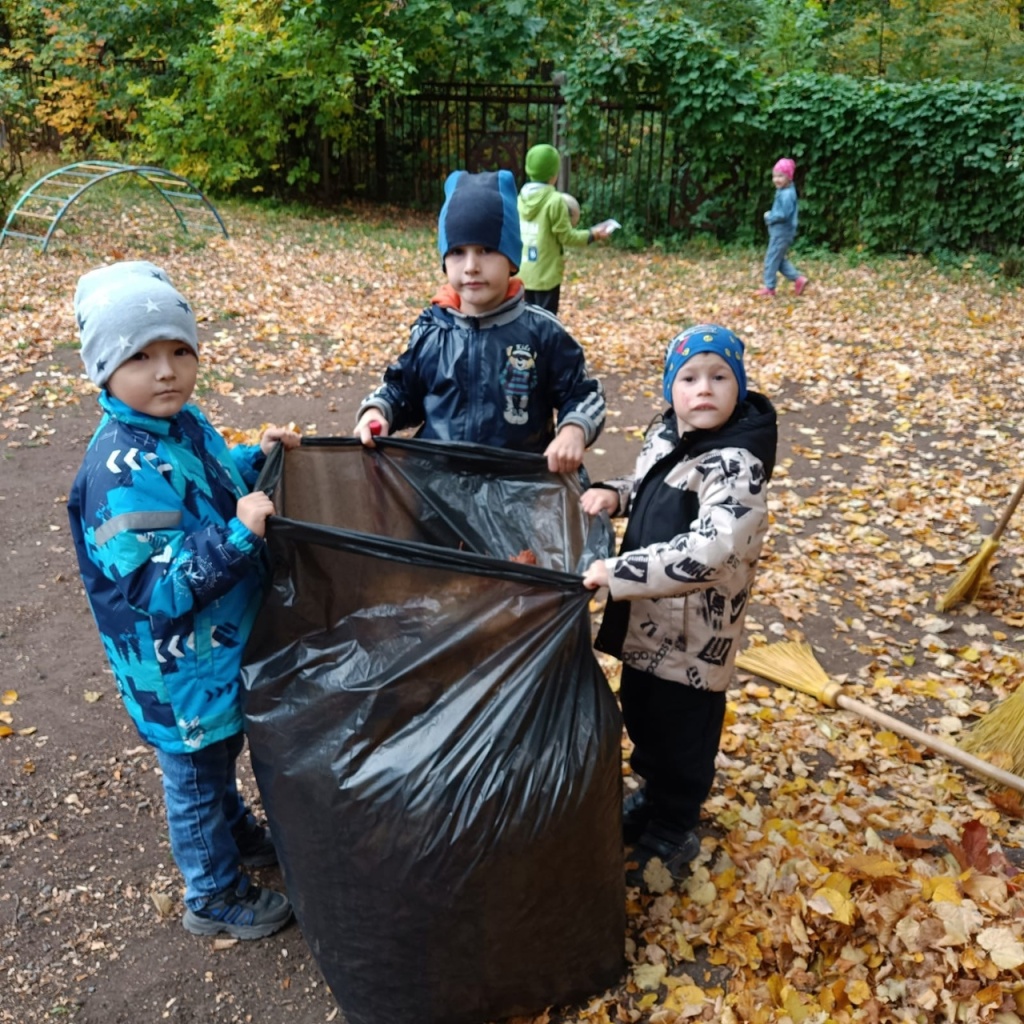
[134,0,412,191]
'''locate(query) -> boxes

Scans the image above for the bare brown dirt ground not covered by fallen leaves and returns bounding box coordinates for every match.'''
[0,356,1021,1024]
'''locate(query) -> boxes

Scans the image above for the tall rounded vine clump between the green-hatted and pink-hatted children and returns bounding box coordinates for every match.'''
[562,0,761,234]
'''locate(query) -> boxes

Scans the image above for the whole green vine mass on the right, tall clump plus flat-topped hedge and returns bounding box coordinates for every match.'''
[563,0,1024,253]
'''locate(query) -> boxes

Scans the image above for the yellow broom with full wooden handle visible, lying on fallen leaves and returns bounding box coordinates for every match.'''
[736,640,1024,793]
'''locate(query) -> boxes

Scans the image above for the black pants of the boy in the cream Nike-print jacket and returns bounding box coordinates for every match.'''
[618,665,725,828]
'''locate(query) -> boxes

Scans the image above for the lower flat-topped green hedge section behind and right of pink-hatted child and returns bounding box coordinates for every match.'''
[763,74,1024,252]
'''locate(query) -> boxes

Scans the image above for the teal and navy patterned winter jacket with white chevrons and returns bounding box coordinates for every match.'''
[68,391,265,754]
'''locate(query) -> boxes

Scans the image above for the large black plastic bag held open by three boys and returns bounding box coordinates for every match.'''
[244,439,626,1024]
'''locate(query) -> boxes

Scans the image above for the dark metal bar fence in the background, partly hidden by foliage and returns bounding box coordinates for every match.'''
[6,67,688,232]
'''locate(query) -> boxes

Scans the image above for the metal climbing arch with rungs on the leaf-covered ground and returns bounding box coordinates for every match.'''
[0,160,227,252]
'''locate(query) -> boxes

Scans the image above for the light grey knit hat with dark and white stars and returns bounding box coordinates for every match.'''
[75,260,199,387]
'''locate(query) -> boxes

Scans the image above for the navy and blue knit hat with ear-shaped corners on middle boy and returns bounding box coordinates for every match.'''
[437,171,522,270]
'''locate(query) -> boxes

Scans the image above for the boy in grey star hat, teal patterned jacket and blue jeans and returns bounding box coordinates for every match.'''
[68,261,300,939]
